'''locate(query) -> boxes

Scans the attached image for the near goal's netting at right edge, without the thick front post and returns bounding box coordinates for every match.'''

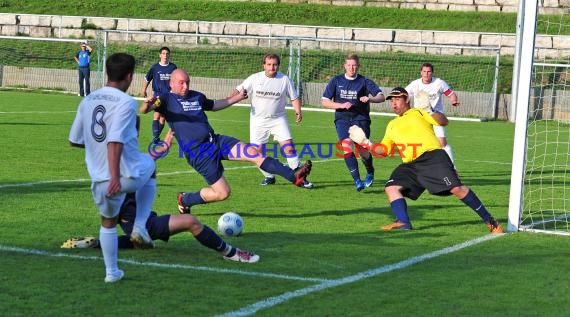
[521,59,570,234]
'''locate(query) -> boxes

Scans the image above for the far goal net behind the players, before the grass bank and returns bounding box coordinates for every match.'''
[99,30,500,119]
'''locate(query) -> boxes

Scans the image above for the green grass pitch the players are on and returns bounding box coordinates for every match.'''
[0,91,570,316]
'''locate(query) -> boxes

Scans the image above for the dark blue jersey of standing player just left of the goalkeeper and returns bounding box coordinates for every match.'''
[323,74,382,121]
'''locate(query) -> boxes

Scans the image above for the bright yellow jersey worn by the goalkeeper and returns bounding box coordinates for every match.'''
[381,108,441,163]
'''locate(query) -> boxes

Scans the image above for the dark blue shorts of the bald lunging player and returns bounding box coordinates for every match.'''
[184,134,239,185]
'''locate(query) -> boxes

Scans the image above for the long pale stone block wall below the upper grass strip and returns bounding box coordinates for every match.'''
[0,13,570,58]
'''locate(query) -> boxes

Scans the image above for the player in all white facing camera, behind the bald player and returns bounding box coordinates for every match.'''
[232,53,313,188]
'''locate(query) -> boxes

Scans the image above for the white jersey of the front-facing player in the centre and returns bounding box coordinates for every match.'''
[236,72,299,118]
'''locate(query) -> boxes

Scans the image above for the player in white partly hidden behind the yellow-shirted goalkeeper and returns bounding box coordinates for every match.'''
[406,63,459,162]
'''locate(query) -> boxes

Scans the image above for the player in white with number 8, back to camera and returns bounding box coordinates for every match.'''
[69,53,156,283]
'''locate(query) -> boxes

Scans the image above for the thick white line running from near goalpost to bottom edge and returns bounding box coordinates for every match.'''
[217,234,502,317]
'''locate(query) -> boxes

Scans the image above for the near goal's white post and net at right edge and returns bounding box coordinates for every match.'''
[509,2,570,235]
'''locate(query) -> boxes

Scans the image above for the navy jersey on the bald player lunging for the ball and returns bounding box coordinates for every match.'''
[155,90,214,154]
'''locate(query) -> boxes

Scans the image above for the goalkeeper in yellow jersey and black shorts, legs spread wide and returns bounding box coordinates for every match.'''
[349,87,503,233]
